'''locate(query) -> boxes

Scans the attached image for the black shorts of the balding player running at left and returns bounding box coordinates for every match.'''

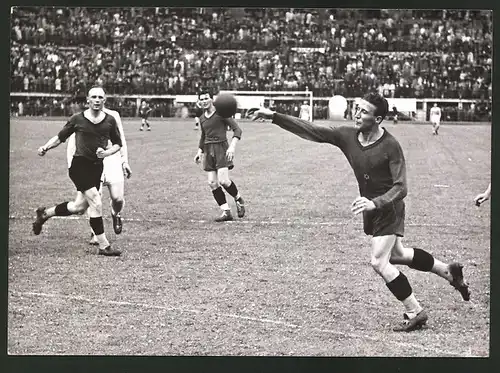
[69,157,103,192]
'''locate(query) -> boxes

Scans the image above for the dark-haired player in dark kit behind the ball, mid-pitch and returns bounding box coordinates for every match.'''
[194,91,245,222]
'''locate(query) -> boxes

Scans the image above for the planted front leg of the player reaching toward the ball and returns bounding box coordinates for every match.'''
[371,235,427,331]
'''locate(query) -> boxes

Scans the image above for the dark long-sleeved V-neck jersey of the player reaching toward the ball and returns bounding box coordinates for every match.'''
[273,113,407,208]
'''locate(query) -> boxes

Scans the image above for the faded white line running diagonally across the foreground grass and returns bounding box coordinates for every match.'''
[10,290,471,357]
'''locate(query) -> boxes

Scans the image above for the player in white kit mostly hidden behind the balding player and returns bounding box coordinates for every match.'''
[66,108,132,244]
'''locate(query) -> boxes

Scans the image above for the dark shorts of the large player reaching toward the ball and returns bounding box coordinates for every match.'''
[363,201,405,237]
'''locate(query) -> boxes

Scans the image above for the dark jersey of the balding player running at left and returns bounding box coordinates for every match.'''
[57,112,122,161]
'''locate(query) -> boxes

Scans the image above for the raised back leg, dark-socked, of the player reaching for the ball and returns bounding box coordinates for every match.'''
[390,237,470,300]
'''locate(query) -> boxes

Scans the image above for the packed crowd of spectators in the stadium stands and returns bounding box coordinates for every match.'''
[11,7,492,117]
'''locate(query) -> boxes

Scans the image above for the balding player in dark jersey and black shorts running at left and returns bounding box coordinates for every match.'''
[33,87,122,256]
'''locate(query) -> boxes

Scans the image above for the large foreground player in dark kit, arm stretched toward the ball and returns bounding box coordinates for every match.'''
[255,93,470,332]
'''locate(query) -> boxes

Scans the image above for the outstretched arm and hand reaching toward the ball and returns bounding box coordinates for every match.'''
[252,108,341,146]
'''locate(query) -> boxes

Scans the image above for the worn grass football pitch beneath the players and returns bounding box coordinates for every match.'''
[8,119,491,357]
